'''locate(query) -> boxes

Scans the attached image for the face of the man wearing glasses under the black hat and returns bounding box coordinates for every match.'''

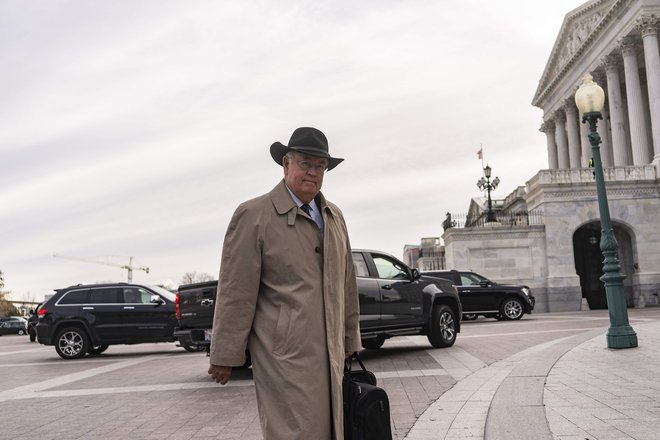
[283,153,328,203]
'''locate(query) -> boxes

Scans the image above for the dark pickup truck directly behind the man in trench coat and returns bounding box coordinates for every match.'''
[174,249,462,351]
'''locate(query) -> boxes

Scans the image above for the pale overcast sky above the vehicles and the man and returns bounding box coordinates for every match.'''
[0,0,583,300]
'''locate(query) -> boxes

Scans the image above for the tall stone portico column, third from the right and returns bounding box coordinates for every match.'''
[603,55,629,167]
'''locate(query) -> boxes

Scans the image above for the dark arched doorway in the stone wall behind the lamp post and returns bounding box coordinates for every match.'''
[573,221,634,309]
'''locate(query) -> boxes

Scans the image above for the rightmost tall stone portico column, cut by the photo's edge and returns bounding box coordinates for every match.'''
[637,15,660,162]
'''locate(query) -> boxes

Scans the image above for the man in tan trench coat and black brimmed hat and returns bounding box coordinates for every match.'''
[209,127,360,440]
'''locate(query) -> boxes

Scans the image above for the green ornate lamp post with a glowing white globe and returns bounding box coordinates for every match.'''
[575,74,637,348]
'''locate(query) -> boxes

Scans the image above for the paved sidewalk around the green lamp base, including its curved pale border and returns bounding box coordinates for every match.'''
[405,314,660,440]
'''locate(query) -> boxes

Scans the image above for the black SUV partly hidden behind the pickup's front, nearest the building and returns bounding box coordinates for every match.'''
[423,270,536,320]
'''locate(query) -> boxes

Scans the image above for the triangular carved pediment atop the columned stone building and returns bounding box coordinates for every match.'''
[532,0,620,107]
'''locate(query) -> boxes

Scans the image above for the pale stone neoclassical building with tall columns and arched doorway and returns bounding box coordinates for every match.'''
[434,0,660,312]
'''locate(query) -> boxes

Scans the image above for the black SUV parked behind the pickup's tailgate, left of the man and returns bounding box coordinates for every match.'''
[36,283,183,359]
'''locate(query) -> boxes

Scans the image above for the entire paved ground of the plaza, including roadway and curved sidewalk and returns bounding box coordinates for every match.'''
[0,307,660,440]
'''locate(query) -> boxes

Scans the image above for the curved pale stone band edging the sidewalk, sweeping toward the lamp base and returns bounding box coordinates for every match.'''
[405,329,603,440]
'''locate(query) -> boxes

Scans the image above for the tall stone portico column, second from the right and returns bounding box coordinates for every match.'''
[619,37,651,165]
